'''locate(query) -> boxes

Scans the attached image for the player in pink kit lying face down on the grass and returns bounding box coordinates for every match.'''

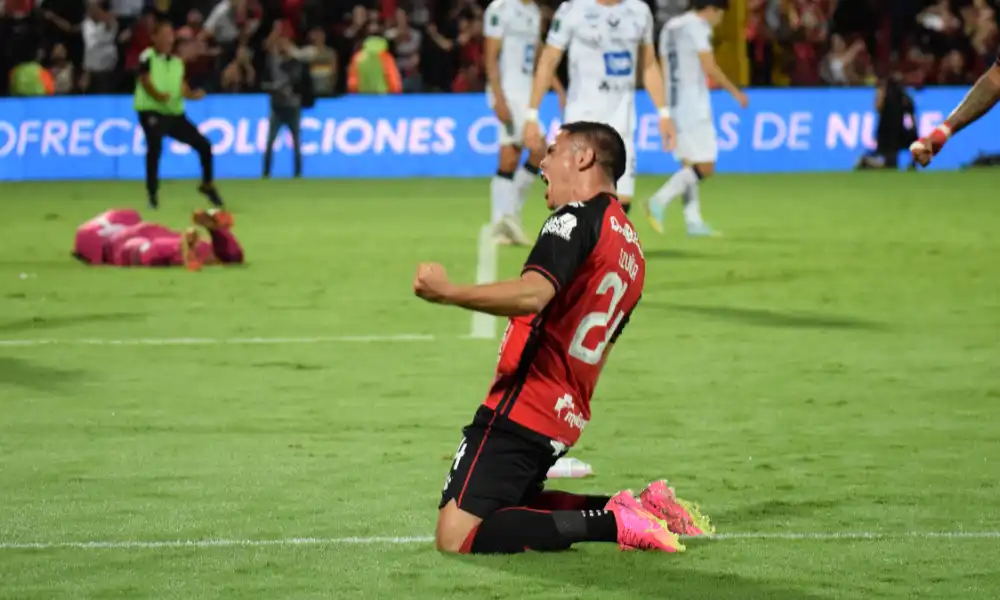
[73,209,243,271]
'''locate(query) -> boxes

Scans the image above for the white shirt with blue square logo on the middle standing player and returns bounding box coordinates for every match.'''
[546,0,653,137]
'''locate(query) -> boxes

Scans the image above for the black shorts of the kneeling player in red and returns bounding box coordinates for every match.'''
[438,406,565,519]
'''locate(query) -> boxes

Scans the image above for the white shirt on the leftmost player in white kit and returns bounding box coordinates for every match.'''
[483,0,542,110]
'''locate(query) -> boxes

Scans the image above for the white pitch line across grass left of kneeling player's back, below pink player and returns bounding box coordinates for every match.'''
[0,333,434,347]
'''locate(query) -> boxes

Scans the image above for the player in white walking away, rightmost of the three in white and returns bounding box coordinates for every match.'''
[647,0,748,236]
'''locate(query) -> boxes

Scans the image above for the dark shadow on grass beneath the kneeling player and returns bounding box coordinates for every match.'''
[460,543,819,600]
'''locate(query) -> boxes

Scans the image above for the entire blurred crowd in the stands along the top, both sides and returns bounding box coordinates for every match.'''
[0,0,998,96]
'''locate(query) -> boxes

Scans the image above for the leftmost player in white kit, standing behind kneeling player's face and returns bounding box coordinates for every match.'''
[483,0,564,245]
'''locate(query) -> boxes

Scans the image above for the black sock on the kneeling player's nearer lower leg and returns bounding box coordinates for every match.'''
[468,507,618,554]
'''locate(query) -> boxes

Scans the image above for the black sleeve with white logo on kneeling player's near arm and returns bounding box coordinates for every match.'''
[521,209,597,292]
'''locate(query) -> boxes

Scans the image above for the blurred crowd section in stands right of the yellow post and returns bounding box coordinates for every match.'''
[746,0,998,87]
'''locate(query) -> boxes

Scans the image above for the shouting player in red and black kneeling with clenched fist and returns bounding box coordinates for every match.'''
[414,122,710,554]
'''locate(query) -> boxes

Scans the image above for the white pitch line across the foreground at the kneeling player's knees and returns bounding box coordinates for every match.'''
[0,531,1000,551]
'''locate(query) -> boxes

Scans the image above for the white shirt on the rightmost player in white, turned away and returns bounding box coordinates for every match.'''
[660,12,712,123]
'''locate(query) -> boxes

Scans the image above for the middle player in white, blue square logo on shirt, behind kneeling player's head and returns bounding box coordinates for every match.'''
[524,0,674,211]
